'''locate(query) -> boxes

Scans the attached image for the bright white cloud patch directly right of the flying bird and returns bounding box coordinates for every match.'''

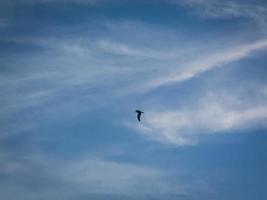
[130,94,267,145]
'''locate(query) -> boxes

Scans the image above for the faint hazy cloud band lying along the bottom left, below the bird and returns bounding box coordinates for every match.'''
[0,155,185,199]
